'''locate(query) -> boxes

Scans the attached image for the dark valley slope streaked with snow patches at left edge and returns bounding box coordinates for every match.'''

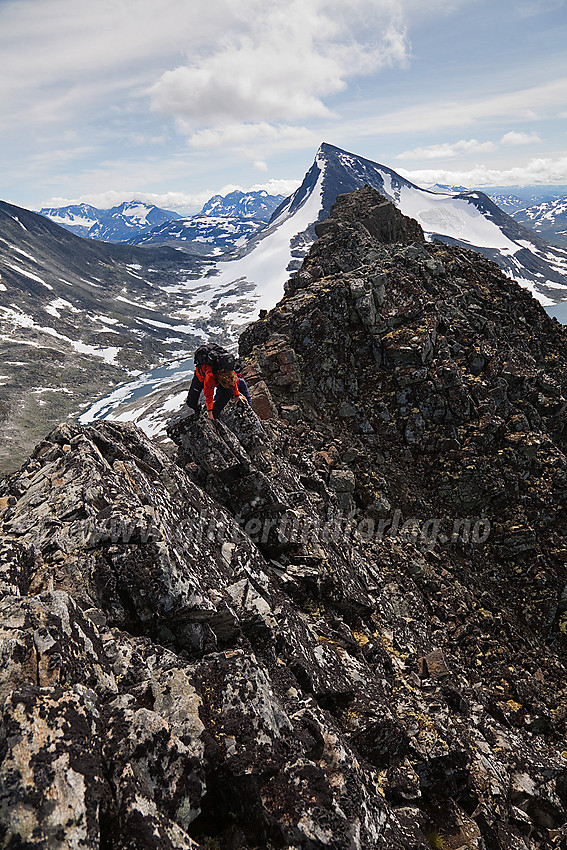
[0,202,255,473]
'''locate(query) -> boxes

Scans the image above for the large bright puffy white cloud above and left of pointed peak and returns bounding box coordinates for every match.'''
[149,0,407,130]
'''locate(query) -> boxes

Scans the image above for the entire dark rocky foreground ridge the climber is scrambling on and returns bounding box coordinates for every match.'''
[0,188,567,850]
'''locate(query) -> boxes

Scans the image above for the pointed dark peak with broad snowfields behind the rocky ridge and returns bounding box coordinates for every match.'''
[209,143,567,308]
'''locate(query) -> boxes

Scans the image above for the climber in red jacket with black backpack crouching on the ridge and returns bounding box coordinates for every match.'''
[186,343,252,419]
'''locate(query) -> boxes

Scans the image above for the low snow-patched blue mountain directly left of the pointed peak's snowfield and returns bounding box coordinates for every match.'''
[128,215,265,257]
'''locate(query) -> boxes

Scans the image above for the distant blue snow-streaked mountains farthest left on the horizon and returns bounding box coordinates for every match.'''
[40,201,180,242]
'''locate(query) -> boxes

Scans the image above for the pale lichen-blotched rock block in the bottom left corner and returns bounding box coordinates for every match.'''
[0,684,106,850]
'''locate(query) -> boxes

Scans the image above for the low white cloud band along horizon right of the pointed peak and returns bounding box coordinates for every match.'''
[398,156,567,187]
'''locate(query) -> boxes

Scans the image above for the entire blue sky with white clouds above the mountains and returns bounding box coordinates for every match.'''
[0,0,567,213]
